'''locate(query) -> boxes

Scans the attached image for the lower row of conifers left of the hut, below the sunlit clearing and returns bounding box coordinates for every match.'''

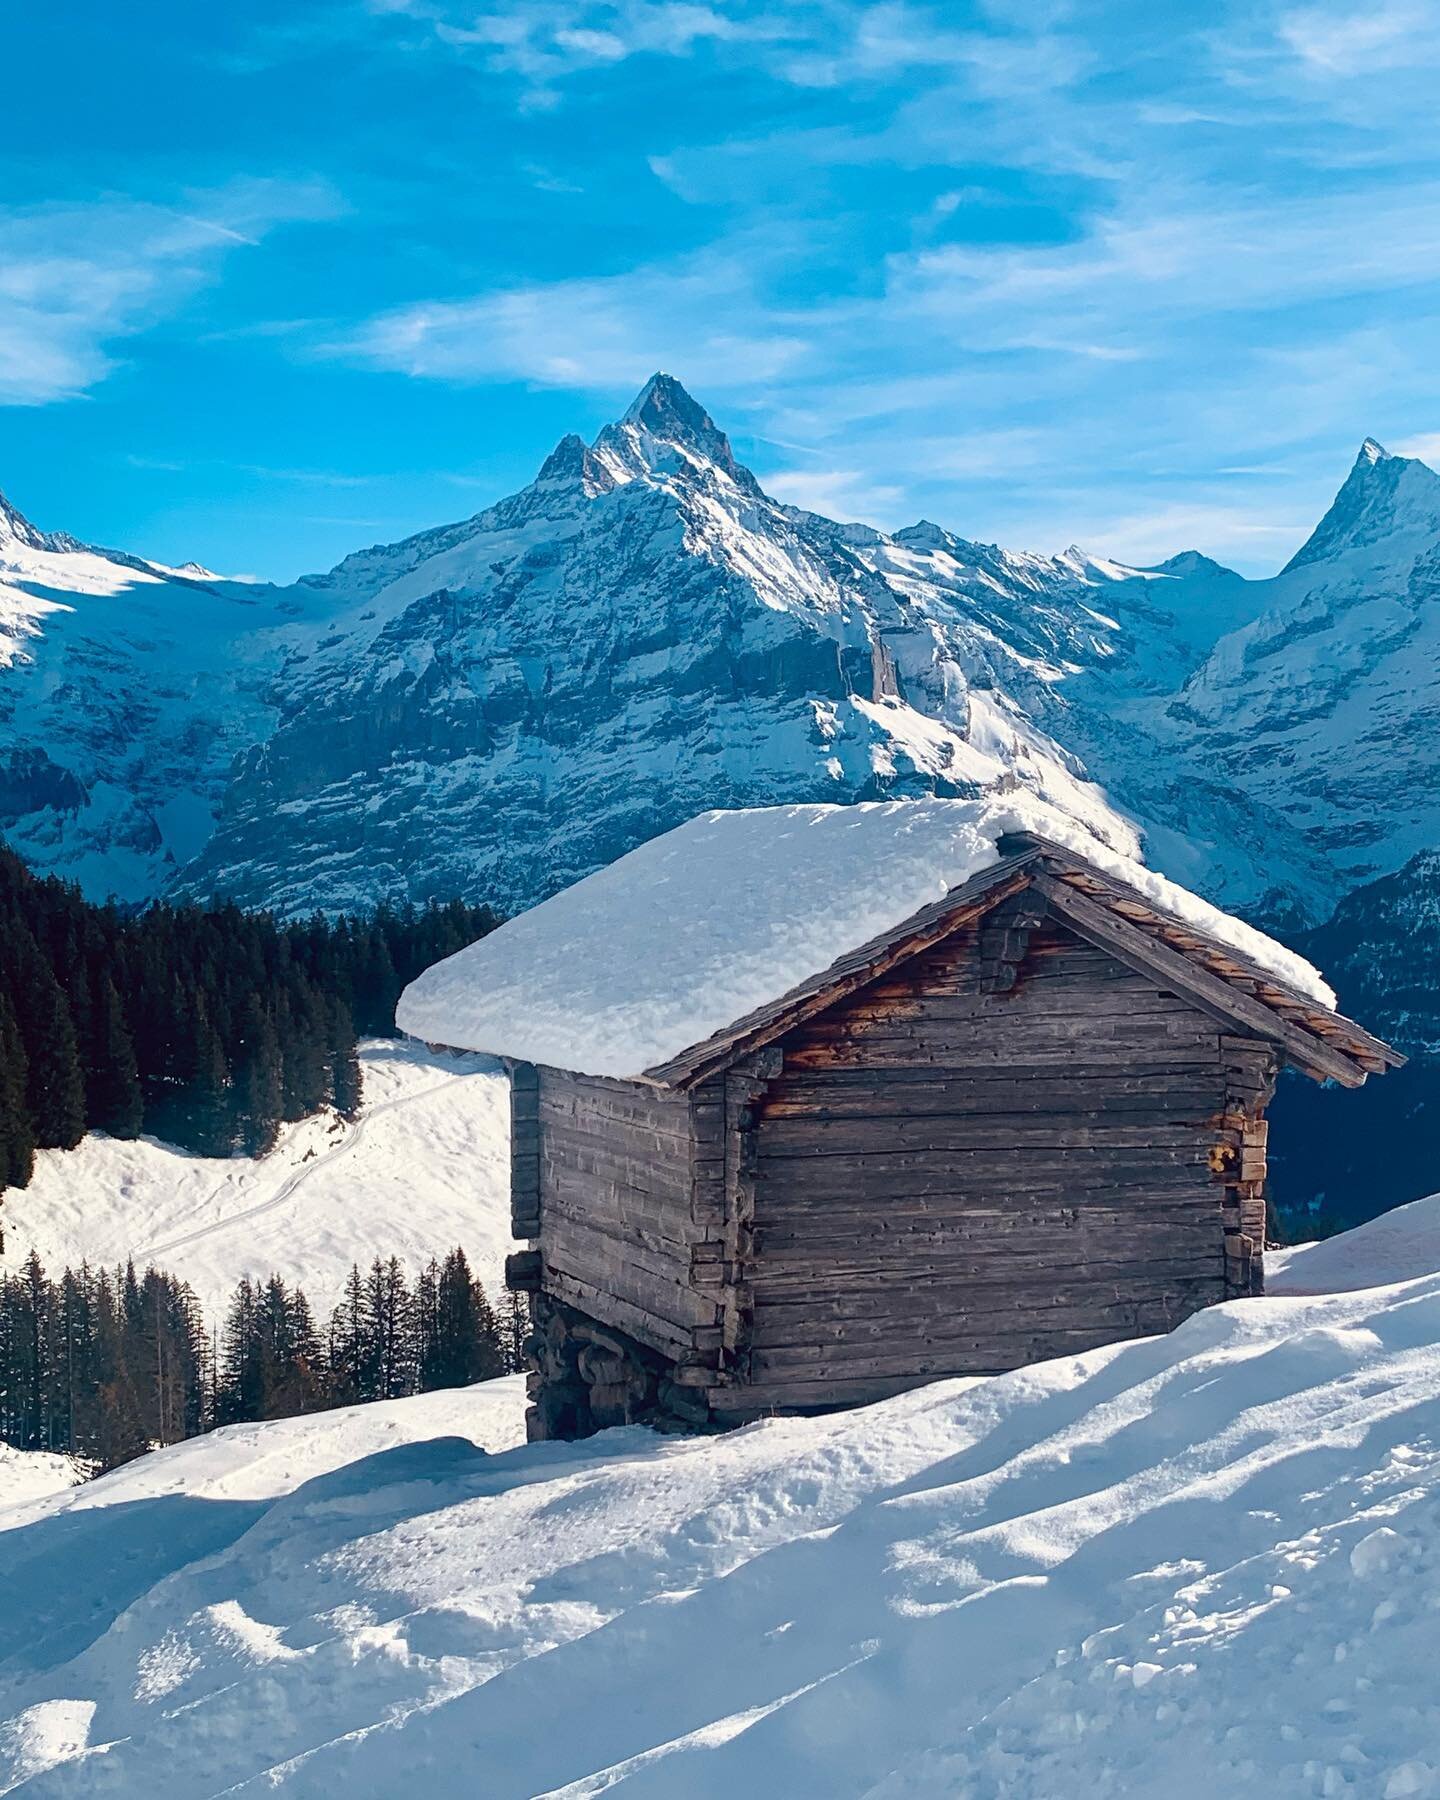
[0,1249,527,1471]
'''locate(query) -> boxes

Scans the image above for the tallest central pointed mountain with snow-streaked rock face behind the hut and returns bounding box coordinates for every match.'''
[171,376,1224,909]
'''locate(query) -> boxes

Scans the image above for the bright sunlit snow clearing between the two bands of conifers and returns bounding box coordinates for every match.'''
[0,1039,509,1319]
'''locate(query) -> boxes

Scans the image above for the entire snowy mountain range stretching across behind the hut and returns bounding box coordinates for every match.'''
[0,376,1440,923]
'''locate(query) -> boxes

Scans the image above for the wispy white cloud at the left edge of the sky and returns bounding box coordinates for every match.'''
[0,180,338,405]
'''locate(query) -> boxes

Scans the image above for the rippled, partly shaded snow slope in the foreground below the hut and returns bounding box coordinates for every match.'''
[0,1278,1440,1800]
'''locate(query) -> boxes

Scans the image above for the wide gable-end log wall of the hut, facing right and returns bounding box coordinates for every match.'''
[741,923,1240,1411]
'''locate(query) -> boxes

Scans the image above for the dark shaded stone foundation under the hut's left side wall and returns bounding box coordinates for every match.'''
[526,1292,715,1444]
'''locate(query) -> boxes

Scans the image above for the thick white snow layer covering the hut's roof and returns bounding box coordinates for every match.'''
[396,794,1336,1076]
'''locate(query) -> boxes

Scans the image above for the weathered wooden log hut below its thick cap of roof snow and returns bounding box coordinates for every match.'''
[394,810,1402,1438]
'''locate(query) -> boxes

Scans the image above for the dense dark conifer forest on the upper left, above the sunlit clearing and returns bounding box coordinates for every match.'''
[0,848,499,1190]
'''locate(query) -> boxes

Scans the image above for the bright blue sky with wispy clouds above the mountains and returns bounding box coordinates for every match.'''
[0,0,1440,578]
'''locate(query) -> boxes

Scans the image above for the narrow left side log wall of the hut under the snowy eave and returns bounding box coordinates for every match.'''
[536,1069,718,1357]
